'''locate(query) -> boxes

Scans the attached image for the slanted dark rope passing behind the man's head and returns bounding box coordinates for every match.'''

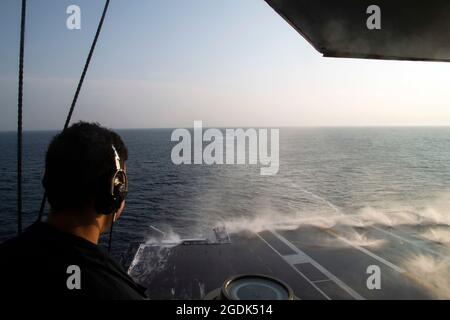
[38,0,110,221]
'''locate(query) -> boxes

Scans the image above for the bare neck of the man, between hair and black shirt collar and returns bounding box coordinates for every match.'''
[47,210,102,244]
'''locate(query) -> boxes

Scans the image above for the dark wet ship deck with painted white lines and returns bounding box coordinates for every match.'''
[125,221,438,300]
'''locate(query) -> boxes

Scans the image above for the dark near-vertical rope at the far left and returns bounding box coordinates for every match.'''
[17,0,27,234]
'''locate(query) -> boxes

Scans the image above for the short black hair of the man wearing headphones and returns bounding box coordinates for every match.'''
[42,121,128,213]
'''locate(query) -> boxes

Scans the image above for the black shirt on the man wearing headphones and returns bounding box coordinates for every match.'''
[0,222,145,299]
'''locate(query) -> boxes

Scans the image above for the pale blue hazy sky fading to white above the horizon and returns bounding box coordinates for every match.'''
[0,0,450,131]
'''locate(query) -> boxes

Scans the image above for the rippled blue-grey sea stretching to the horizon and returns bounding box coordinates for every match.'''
[0,127,450,262]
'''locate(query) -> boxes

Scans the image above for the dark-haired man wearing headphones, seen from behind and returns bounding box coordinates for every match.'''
[0,122,145,299]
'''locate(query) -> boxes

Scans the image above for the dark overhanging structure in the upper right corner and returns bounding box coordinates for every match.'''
[265,0,450,62]
